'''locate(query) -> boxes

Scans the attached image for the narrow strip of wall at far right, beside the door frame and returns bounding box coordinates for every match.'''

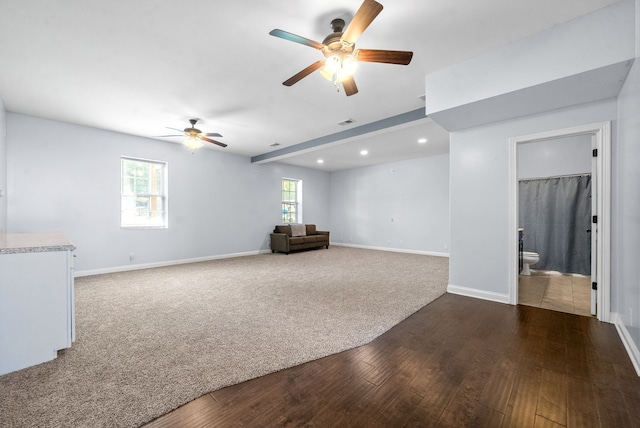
[611,0,640,374]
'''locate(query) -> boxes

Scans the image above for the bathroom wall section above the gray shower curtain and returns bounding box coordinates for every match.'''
[517,135,592,179]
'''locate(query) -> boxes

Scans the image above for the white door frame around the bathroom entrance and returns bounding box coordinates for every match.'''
[508,122,611,322]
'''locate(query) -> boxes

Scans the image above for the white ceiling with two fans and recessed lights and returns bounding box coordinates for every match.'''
[0,0,618,171]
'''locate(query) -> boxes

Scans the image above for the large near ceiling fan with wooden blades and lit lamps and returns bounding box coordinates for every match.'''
[269,0,413,96]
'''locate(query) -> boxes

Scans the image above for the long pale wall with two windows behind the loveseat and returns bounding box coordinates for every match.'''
[7,113,329,272]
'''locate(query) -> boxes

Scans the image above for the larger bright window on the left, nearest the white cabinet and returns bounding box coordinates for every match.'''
[120,157,167,228]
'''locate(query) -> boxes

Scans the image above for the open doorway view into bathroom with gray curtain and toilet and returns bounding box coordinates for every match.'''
[516,134,595,316]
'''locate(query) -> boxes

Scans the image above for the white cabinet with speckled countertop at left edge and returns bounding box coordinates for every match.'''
[0,233,75,375]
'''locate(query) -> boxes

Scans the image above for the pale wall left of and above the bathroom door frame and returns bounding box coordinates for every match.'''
[449,99,617,302]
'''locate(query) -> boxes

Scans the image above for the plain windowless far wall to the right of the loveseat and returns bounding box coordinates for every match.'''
[330,155,449,255]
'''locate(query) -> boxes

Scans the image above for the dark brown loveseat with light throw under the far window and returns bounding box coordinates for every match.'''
[271,224,329,254]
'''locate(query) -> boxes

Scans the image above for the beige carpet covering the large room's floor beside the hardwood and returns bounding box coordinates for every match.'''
[0,246,448,427]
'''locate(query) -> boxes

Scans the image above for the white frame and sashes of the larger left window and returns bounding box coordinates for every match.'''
[120,156,169,229]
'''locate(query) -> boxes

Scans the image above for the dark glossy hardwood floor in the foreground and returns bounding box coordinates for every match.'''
[146,294,640,428]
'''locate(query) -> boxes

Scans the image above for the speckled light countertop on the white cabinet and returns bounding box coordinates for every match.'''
[0,232,76,254]
